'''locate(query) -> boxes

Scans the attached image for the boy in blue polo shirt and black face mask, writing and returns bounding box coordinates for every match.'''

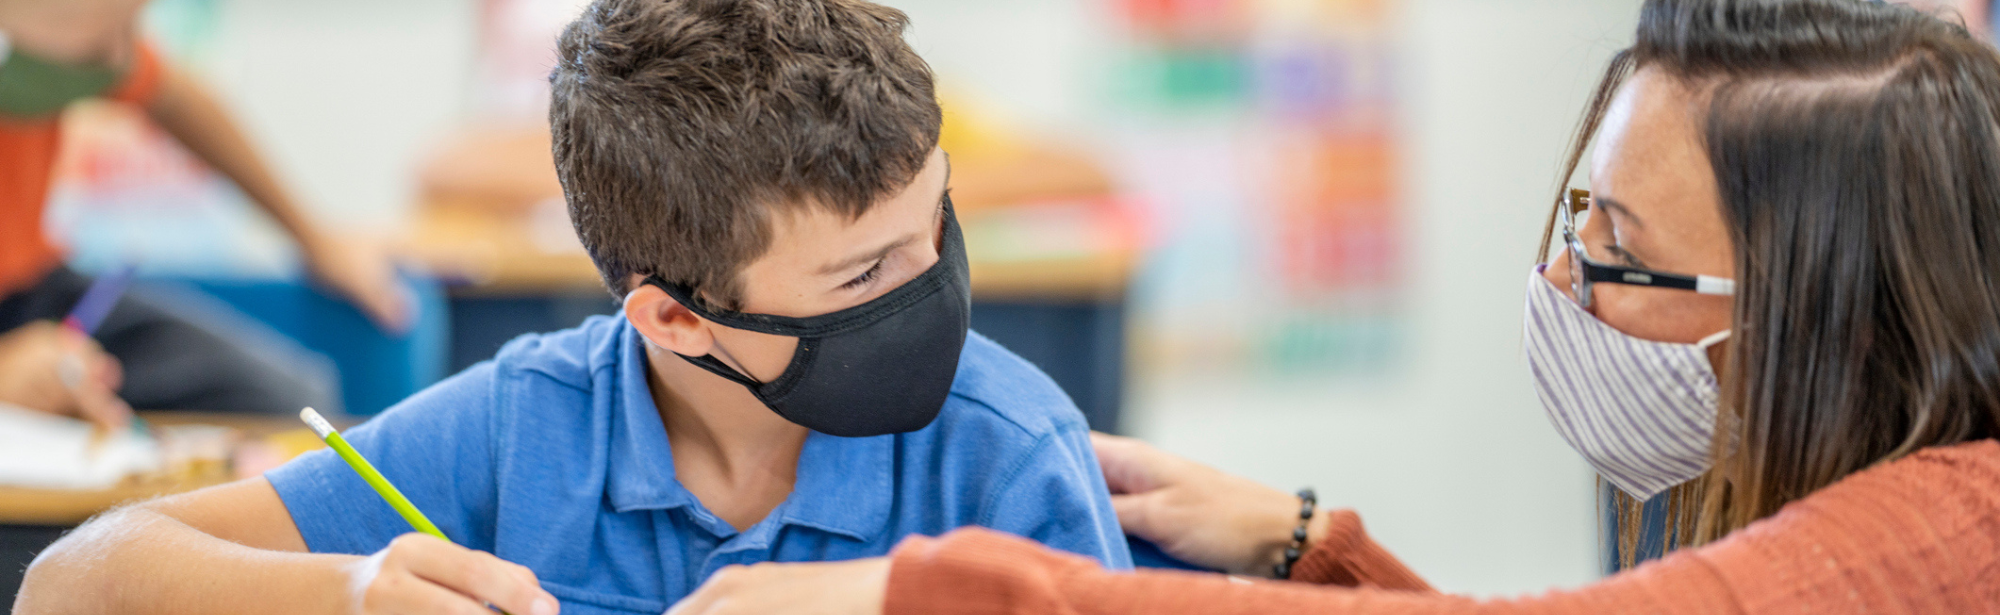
[16,0,1130,615]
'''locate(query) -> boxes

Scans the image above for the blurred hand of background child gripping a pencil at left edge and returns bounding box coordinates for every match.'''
[0,319,132,431]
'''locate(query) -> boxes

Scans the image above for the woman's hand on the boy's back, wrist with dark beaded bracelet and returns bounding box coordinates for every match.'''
[1090,433,1326,577]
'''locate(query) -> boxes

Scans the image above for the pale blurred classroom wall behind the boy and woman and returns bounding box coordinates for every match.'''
[195,0,1638,595]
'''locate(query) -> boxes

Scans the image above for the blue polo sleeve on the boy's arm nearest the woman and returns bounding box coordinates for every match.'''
[978,421,1132,571]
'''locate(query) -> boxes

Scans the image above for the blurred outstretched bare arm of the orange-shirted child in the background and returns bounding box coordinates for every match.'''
[146,62,414,331]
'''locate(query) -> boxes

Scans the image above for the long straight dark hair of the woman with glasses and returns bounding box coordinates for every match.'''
[1542,0,2000,553]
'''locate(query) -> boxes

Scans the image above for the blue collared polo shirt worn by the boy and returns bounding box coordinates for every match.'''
[266,317,1132,615]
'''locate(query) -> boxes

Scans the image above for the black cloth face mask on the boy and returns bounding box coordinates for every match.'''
[646,202,972,437]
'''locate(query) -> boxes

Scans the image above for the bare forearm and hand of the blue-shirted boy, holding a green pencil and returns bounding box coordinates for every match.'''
[14,477,556,615]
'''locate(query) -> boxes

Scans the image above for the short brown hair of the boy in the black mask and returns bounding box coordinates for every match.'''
[548,0,942,309]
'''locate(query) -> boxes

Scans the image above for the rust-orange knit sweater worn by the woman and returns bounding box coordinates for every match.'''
[884,439,2000,615]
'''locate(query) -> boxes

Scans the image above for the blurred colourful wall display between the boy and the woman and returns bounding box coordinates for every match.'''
[1104,0,1406,377]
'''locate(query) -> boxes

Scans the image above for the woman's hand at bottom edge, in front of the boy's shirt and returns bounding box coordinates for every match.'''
[666,557,890,615]
